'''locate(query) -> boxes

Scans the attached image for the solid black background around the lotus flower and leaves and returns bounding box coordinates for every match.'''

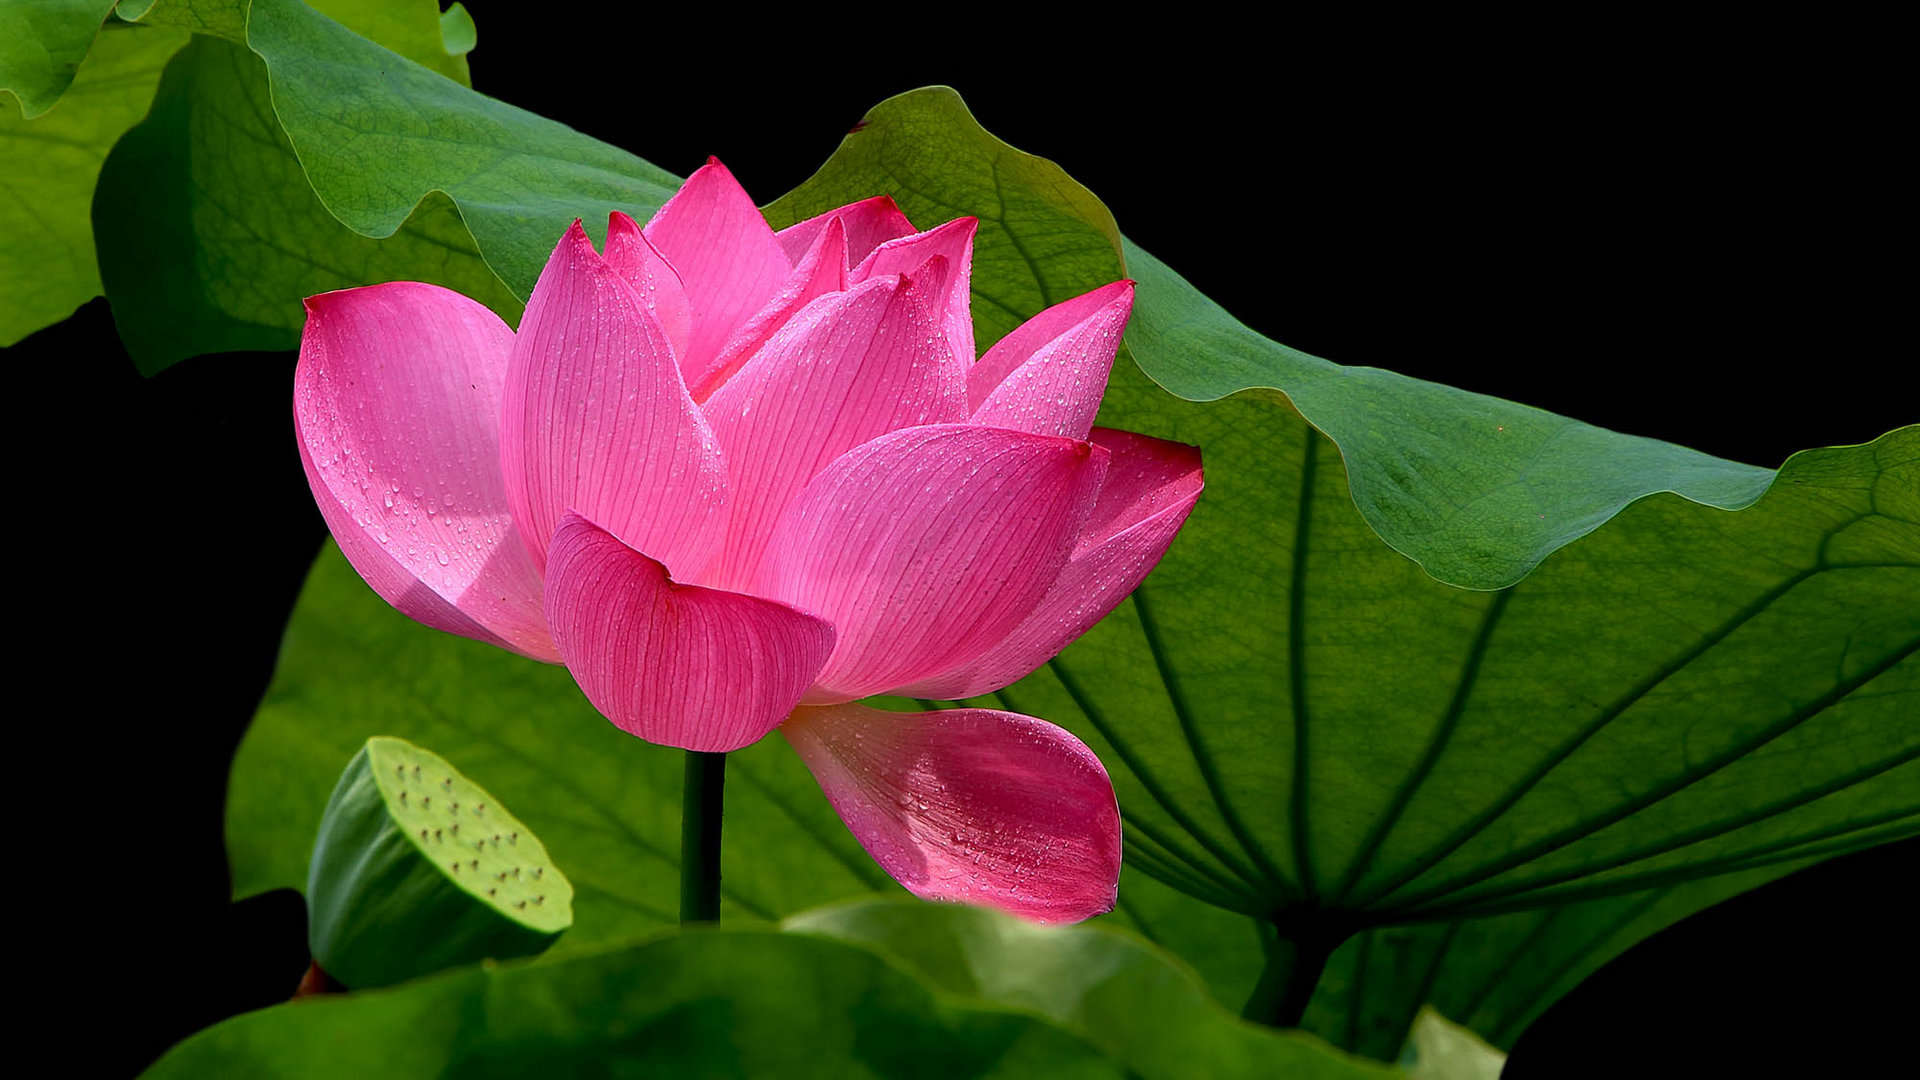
[22,4,1920,1078]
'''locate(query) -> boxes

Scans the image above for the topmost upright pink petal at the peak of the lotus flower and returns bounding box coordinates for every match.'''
[645,158,793,384]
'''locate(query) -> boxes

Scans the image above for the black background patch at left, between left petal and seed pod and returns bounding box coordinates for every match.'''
[21,300,324,1076]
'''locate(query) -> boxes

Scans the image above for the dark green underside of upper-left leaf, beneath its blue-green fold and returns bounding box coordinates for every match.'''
[94,0,518,373]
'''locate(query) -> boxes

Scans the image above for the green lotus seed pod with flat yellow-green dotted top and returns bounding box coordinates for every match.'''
[307,736,574,990]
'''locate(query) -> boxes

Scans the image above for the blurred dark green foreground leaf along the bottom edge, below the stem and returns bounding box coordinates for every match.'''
[148,930,1125,1080]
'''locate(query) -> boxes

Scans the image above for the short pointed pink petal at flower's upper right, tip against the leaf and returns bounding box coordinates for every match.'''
[968,281,1133,438]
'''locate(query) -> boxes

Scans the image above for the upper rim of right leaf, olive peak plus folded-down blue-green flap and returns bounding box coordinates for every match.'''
[766,86,1772,588]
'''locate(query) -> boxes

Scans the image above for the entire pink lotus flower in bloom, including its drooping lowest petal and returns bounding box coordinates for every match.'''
[294,161,1200,920]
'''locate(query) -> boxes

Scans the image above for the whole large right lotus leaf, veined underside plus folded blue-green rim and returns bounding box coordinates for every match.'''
[770,90,1920,1040]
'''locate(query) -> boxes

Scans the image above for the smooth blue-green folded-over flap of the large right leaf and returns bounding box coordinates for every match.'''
[1125,244,1774,588]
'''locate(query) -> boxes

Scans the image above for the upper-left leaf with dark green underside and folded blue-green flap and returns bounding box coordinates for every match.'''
[96,0,678,375]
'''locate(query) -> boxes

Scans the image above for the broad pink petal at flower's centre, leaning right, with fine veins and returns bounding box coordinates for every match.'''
[703,267,966,588]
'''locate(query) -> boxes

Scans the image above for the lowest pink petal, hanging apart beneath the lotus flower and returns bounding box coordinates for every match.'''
[780,705,1119,922]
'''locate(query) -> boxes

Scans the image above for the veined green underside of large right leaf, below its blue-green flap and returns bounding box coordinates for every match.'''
[944,417,1920,922]
